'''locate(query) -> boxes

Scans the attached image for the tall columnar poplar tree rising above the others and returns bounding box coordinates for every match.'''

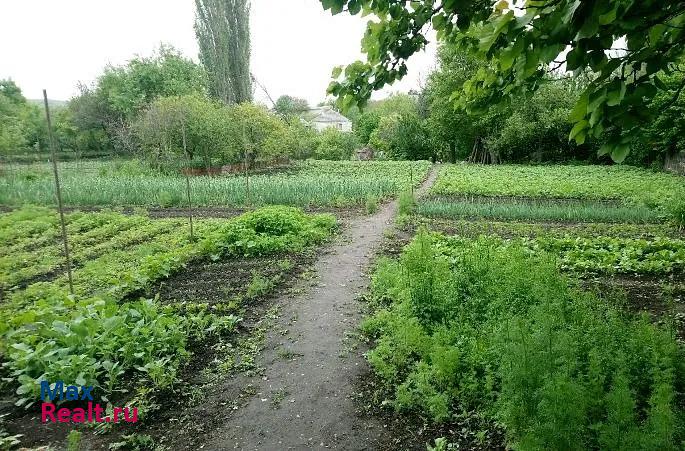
[195,0,252,104]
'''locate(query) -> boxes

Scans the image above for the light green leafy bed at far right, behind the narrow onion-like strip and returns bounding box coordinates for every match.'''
[431,164,685,208]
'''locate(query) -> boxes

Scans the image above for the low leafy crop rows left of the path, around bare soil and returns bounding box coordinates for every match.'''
[0,206,336,412]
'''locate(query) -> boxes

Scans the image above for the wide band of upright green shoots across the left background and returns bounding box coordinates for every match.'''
[0,161,430,207]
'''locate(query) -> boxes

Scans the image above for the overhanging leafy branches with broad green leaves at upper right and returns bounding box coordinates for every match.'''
[321,0,685,161]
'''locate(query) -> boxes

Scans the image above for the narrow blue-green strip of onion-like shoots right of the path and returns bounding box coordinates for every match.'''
[416,198,663,224]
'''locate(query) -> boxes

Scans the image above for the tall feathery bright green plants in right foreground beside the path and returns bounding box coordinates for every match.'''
[363,231,685,449]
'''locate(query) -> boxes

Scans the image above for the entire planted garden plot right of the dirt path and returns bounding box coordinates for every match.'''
[363,164,685,450]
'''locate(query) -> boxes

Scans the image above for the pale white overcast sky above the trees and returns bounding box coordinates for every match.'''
[0,0,436,105]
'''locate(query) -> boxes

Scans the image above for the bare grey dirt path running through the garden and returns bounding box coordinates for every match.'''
[203,168,437,450]
